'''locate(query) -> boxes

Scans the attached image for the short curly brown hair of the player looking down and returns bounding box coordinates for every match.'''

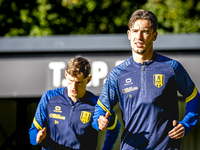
[66,56,91,78]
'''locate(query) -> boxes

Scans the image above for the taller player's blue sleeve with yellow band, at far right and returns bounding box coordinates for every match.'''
[171,63,200,137]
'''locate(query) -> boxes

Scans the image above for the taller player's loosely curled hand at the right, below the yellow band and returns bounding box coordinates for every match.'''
[168,120,184,139]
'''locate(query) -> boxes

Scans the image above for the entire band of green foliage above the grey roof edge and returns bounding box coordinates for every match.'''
[0,0,200,36]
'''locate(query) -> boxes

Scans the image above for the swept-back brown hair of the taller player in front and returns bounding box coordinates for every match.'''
[128,9,157,32]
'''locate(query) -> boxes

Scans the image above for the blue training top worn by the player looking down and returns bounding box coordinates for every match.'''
[29,87,120,150]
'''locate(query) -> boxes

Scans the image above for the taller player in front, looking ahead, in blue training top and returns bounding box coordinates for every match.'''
[92,9,200,150]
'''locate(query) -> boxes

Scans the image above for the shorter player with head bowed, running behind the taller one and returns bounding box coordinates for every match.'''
[29,57,121,150]
